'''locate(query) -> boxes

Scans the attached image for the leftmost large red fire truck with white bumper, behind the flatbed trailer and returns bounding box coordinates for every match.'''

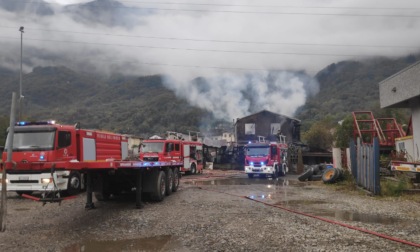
[3,121,128,195]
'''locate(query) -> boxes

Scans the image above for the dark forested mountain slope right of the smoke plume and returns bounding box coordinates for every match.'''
[295,55,420,130]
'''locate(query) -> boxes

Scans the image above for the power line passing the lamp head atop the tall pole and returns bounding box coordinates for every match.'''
[0,25,418,49]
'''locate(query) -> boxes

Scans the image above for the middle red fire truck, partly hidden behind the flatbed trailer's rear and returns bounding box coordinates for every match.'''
[140,135,203,174]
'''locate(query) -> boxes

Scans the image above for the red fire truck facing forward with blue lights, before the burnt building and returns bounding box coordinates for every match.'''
[244,135,288,178]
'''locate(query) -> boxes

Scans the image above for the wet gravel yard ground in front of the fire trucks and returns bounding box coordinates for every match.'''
[0,170,420,252]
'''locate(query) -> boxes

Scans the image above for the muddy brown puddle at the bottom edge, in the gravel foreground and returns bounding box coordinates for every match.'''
[62,235,181,252]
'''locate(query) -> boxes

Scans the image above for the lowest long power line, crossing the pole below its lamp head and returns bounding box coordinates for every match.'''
[0,36,390,57]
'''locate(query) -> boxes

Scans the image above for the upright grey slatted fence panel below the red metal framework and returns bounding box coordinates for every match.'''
[350,138,381,195]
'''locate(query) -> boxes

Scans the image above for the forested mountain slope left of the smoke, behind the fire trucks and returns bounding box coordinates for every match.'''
[0,67,211,136]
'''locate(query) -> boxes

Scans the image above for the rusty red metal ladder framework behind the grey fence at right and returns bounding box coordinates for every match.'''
[352,111,405,148]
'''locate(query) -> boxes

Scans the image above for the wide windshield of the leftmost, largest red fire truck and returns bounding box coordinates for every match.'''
[6,131,55,151]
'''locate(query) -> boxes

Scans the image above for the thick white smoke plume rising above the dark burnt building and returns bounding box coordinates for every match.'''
[165,71,319,121]
